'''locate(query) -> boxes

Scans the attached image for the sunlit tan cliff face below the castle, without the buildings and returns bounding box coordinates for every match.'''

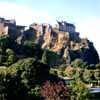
[18,23,99,64]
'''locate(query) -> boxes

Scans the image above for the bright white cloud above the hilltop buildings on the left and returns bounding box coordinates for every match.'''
[0,2,51,25]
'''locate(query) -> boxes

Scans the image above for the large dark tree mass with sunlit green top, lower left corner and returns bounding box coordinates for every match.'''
[0,58,49,100]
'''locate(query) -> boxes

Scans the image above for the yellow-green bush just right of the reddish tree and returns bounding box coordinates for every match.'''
[70,80,90,100]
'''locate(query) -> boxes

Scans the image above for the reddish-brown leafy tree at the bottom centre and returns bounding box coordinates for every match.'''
[40,81,69,100]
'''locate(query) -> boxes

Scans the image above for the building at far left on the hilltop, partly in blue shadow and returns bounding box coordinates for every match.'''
[0,18,26,38]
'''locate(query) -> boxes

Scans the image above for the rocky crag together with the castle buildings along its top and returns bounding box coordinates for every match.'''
[0,19,99,64]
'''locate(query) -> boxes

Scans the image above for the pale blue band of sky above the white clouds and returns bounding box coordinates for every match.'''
[0,0,100,23]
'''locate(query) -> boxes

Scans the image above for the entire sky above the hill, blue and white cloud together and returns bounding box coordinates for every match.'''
[0,0,100,54]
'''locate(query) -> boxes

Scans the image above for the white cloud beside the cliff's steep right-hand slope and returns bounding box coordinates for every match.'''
[77,18,100,55]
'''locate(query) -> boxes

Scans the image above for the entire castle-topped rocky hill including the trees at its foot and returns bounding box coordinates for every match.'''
[0,19,100,100]
